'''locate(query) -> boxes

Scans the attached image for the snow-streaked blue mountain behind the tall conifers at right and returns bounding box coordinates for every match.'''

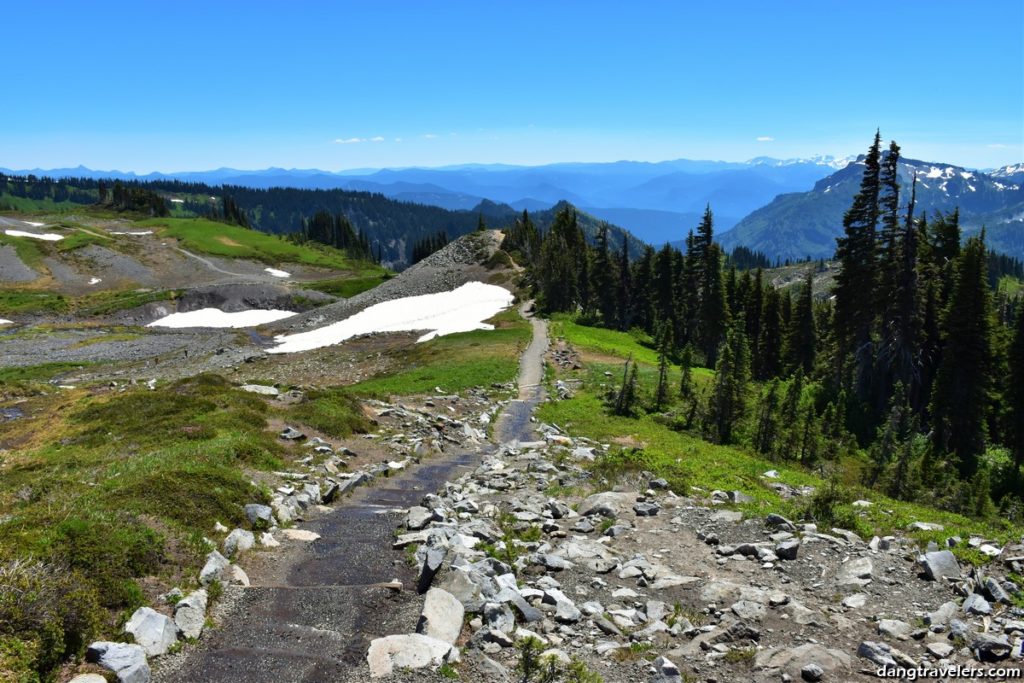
[720,159,1024,259]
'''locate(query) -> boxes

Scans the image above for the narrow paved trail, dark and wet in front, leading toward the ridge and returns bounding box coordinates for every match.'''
[154,304,548,683]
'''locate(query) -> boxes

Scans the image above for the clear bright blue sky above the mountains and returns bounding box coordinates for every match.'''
[0,0,1024,172]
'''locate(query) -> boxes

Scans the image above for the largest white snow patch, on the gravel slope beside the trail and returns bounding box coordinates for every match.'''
[267,283,512,353]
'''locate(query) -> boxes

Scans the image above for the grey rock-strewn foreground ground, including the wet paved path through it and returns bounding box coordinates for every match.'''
[74,305,1024,683]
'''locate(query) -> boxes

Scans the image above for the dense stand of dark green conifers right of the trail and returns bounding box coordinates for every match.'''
[512,134,1024,514]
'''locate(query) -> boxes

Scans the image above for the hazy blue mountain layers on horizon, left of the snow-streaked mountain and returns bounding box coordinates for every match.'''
[0,157,851,245]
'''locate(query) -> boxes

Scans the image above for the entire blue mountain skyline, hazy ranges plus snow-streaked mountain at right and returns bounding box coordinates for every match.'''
[0,157,1024,259]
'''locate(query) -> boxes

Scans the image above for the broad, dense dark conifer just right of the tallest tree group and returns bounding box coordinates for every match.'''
[931,231,992,479]
